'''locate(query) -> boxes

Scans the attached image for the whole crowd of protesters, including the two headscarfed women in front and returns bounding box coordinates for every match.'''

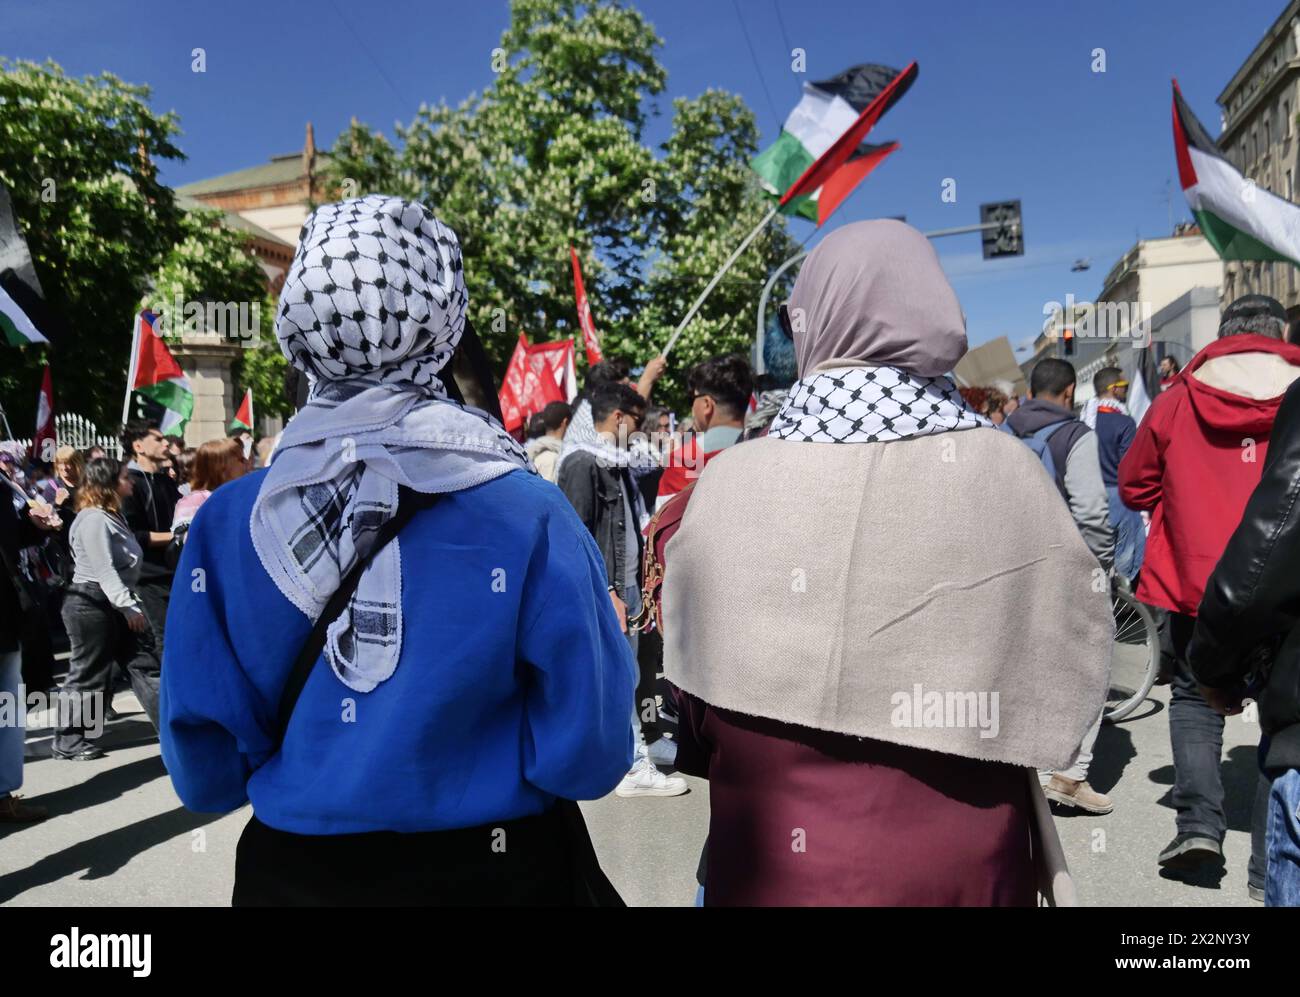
[0,195,1300,905]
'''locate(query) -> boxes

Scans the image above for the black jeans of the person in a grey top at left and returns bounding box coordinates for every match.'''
[55,585,160,754]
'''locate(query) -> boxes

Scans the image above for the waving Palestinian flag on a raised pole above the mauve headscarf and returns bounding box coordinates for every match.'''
[750,62,918,225]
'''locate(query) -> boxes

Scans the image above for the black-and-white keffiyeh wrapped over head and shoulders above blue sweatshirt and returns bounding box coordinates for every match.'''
[250,194,533,692]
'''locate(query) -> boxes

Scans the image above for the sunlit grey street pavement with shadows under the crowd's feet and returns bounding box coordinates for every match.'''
[0,689,1258,907]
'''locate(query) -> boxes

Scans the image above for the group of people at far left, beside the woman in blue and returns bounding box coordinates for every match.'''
[0,420,251,823]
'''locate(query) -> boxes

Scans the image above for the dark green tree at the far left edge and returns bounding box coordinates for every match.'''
[0,60,183,434]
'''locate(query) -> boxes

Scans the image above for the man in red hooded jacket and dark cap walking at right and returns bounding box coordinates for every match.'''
[1119,295,1300,884]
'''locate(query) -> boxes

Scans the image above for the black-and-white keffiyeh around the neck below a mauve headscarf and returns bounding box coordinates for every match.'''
[767,367,993,443]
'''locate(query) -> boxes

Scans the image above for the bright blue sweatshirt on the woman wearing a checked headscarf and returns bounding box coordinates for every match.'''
[161,471,636,835]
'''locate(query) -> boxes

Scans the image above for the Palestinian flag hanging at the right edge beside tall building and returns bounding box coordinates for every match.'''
[1174,79,1300,265]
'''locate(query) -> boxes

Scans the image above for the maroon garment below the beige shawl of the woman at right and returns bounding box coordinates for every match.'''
[679,697,1036,906]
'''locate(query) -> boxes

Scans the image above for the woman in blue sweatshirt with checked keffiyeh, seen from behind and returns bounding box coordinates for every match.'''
[161,195,636,905]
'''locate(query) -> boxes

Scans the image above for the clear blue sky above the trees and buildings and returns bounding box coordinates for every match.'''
[0,0,1286,353]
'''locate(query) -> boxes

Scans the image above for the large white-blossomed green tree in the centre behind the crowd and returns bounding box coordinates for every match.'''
[318,0,794,403]
